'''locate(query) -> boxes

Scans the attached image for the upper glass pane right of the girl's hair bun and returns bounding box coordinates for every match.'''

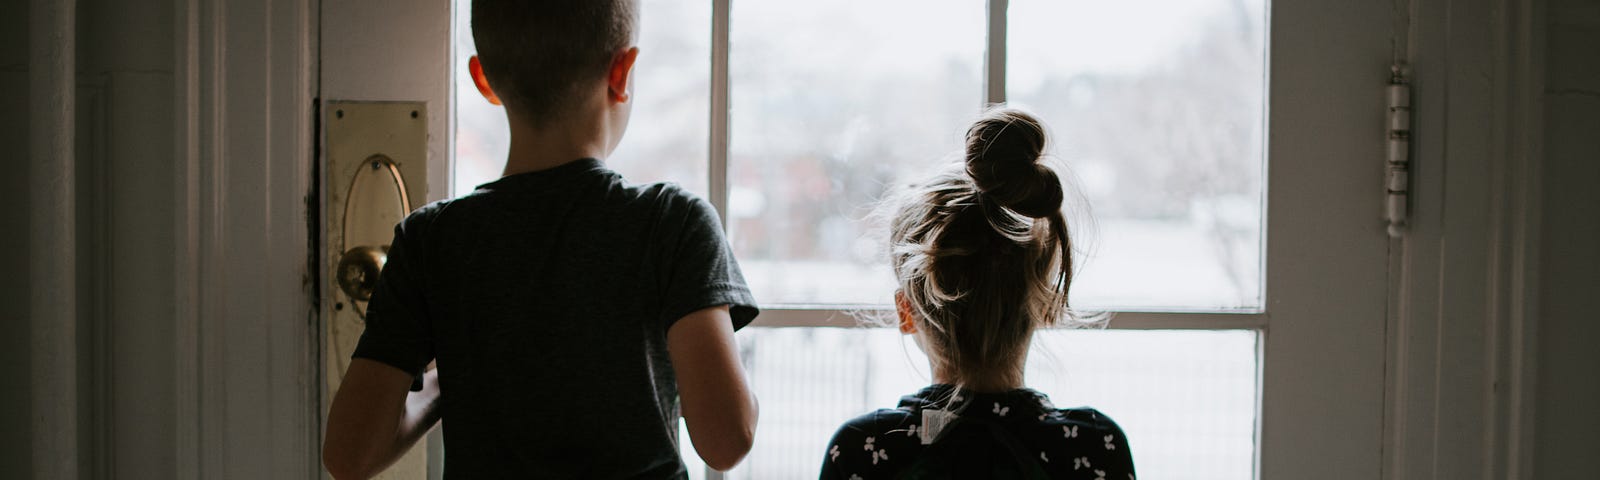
[1006,0,1266,310]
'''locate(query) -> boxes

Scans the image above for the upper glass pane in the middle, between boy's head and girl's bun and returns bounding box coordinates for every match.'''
[728,0,986,304]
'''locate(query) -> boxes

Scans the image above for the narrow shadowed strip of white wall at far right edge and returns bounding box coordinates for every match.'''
[1534,0,1600,480]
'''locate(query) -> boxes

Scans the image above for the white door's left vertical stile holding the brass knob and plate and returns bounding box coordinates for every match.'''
[318,0,451,480]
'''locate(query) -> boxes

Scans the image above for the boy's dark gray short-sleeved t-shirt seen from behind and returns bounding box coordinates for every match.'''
[354,158,757,478]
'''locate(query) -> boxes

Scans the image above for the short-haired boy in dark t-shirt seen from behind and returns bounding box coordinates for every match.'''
[323,0,757,480]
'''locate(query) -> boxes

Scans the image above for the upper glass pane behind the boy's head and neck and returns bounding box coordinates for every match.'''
[451,0,710,197]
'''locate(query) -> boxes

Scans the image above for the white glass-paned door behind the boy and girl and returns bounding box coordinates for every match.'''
[334,0,1390,478]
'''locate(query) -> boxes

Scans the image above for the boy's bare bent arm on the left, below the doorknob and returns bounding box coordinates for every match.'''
[322,358,438,480]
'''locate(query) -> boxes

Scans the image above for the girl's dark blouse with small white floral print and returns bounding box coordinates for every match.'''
[821,384,1134,480]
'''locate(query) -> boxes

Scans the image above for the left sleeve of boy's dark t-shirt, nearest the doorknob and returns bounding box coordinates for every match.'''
[350,219,434,390]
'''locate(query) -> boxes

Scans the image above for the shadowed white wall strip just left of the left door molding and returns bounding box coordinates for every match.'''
[77,0,178,478]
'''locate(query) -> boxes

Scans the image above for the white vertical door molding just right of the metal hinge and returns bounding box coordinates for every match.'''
[1374,0,1542,478]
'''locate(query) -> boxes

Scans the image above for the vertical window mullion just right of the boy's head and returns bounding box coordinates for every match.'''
[707,0,733,229]
